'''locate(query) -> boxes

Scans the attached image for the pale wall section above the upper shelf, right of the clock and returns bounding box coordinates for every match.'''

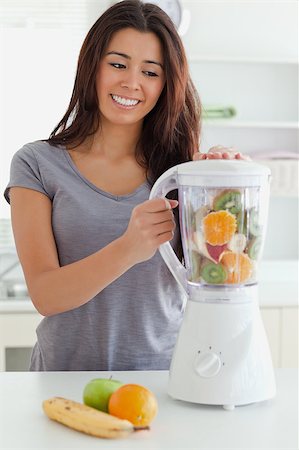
[183,0,298,61]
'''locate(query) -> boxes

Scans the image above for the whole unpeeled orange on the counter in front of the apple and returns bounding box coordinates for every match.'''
[108,384,158,427]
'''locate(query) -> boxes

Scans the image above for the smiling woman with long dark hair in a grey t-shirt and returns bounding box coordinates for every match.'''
[5,1,246,370]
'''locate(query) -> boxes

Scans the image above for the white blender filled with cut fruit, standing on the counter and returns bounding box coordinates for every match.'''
[150,160,276,410]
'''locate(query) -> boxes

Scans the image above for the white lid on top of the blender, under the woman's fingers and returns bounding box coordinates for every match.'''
[177,159,271,187]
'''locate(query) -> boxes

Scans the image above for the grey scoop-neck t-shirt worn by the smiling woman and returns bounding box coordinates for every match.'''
[5,141,185,371]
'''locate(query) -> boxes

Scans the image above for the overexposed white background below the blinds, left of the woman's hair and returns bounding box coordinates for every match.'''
[0,28,82,217]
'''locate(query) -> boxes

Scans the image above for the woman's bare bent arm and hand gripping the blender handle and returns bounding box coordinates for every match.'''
[10,187,177,316]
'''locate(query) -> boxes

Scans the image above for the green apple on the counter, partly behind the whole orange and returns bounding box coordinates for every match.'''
[83,378,123,412]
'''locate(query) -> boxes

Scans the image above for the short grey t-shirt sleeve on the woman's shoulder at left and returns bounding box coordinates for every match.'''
[4,144,50,203]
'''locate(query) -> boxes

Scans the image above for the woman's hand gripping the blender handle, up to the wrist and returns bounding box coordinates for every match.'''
[122,198,178,264]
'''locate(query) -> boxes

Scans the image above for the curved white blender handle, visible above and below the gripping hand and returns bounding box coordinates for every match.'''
[149,166,188,295]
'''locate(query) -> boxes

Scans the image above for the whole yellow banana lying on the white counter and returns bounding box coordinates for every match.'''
[43,397,148,438]
